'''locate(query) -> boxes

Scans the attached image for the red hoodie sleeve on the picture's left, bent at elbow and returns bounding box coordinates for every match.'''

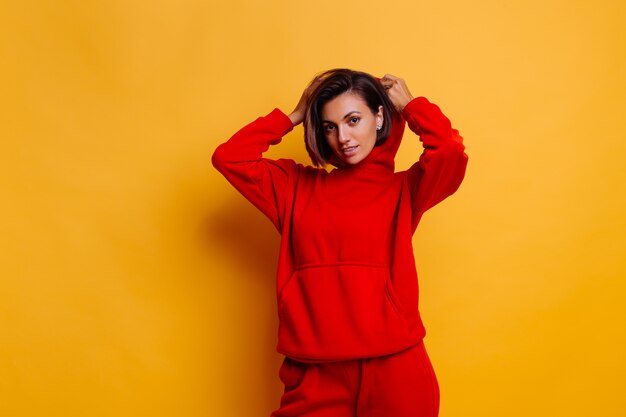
[211,108,297,231]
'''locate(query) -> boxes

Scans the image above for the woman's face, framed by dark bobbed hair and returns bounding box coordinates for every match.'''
[322,92,383,165]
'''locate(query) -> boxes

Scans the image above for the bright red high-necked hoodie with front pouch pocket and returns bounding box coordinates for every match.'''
[212,97,468,362]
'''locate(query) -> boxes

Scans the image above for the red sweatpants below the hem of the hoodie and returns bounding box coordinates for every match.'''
[271,343,439,417]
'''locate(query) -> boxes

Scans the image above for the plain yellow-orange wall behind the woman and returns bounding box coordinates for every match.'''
[0,0,626,417]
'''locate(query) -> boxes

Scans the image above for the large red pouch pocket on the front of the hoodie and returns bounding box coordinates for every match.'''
[278,263,408,360]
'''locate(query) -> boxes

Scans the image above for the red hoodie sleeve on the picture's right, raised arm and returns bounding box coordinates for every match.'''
[402,97,468,228]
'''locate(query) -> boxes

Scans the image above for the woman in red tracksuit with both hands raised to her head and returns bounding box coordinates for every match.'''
[213,69,467,417]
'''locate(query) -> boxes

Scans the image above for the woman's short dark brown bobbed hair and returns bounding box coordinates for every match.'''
[304,68,395,166]
